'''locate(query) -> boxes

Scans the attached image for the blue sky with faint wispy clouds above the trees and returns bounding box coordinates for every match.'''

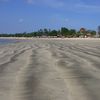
[0,0,100,33]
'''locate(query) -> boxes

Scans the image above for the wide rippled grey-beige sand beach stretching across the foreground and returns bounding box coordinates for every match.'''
[0,38,100,100]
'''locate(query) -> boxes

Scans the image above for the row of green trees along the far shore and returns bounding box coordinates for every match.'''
[0,27,96,38]
